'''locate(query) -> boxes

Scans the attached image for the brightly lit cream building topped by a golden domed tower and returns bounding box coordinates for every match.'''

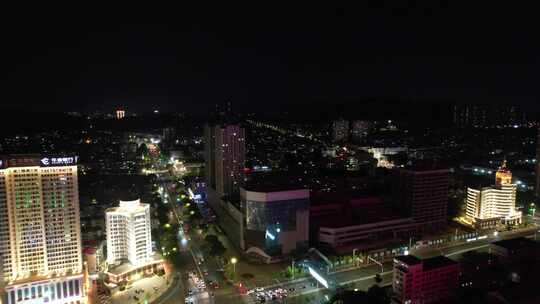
[466,161,521,228]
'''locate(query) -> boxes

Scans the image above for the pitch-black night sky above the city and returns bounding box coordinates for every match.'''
[1,1,540,111]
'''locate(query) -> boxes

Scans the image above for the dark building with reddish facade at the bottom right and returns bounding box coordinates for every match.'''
[392,255,459,304]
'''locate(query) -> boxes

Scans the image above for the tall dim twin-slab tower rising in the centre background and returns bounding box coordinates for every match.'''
[205,124,246,196]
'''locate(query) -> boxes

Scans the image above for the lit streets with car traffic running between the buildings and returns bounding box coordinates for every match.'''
[149,156,536,304]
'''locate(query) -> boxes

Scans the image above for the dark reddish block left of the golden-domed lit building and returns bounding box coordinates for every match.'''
[396,167,450,228]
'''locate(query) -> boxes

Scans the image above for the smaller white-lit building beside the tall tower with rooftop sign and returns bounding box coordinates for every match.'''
[105,200,153,266]
